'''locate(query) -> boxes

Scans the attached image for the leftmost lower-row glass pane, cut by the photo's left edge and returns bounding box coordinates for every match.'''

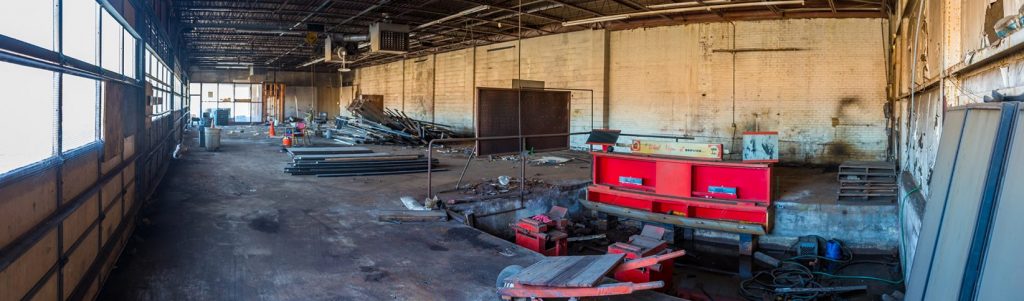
[0,61,56,173]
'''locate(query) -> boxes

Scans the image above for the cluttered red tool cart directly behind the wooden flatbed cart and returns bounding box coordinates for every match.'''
[608,224,675,293]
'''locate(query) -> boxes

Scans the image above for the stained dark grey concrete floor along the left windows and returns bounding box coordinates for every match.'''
[99,128,676,300]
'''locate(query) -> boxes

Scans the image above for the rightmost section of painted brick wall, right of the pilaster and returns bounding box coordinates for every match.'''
[609,19,886,163]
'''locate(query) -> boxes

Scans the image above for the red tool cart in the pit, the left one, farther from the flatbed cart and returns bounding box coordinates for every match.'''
[512,206,568,256]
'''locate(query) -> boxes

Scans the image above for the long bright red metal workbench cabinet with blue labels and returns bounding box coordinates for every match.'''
[587,153,772,230]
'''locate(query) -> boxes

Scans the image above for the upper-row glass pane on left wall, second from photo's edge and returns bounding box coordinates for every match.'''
[62,0,99,65]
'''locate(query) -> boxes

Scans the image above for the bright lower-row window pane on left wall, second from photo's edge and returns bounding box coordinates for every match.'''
[60,74,99,152]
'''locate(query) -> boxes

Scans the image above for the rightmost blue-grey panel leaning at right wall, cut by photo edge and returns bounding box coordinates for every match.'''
[977,107,1024,300]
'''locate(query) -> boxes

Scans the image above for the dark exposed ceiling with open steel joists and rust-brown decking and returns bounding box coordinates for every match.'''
[173,0,888,71]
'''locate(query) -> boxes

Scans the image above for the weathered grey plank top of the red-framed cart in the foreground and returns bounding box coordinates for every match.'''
[509,254,624,288]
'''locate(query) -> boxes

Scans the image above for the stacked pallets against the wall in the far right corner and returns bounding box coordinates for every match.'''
[839,161,898,202]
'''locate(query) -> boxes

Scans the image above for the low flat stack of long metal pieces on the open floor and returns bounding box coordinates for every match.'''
[285,146,443,177]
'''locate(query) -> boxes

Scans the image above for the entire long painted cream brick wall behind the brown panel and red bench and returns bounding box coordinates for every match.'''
[356,18,886,163]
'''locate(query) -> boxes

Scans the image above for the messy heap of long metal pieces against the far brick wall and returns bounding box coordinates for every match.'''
[331,99,456,145]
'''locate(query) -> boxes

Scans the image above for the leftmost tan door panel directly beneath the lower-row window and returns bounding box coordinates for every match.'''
[0,168,57,246]
